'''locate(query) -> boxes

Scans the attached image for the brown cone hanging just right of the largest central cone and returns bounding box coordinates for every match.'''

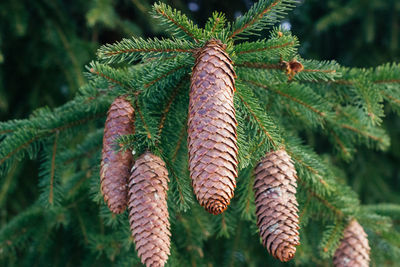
[254,149,300,262]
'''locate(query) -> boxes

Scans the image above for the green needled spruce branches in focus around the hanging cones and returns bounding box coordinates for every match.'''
[0,0,400,266]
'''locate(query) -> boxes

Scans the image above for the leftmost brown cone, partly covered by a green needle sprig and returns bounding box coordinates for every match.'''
[100,97,135,214]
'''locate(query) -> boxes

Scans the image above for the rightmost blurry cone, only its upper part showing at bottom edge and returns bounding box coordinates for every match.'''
[333,220,371,267]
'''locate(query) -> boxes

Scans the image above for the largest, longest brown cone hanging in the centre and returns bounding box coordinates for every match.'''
[188,40,238,214]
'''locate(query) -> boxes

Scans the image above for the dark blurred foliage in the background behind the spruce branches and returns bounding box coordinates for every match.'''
[0,0,400,266]
